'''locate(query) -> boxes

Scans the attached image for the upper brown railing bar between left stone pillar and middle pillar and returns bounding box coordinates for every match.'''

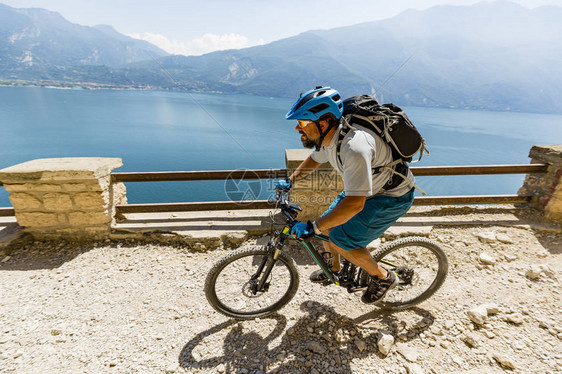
[111,169,287,182]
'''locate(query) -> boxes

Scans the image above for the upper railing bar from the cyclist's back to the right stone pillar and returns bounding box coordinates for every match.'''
[411,164,548,177]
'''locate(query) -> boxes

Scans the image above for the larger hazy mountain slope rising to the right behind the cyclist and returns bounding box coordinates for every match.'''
[131,2,562,112]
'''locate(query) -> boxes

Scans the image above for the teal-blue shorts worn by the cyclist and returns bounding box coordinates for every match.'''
[322,190,414,251]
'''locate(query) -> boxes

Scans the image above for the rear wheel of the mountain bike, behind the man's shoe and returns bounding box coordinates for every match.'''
[373,237,449,310]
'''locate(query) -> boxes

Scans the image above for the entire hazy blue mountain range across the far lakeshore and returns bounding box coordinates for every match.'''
[0,1,562,113]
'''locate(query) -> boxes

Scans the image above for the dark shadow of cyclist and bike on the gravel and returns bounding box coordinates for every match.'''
[179,301,434,373]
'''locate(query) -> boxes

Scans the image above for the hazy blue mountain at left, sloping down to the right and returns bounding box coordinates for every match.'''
[0,4,167,79]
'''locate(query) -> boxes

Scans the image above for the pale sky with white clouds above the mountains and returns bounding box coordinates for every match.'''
[0,0,562,55]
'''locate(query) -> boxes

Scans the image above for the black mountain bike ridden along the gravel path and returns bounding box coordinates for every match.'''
[204,191,448,319]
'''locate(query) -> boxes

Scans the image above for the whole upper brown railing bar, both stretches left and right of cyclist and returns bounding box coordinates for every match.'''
[111,164,548,182]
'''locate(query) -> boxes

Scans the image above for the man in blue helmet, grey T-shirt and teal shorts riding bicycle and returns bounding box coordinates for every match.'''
[276,87,414,304]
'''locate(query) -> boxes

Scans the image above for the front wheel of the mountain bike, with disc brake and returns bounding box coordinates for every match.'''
[205,246,299,319]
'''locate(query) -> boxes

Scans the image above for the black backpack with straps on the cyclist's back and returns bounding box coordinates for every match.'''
[336,95,429,193]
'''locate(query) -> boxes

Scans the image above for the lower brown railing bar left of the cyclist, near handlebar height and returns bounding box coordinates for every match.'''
[116,200,275,213]
